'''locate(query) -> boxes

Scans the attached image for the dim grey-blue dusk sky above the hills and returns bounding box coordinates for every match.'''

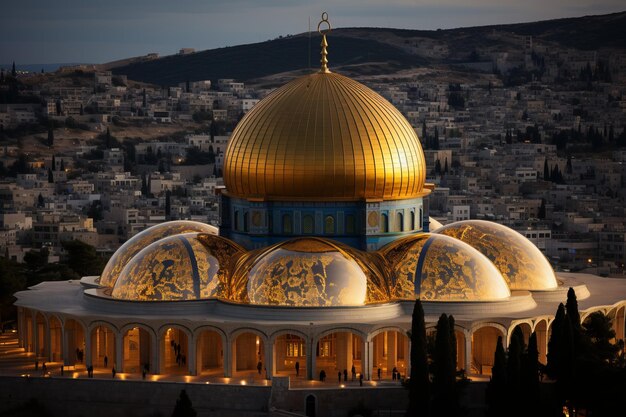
[0,0,625,64]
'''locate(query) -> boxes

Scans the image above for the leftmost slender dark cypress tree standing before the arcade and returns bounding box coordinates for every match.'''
[406,299,430,417]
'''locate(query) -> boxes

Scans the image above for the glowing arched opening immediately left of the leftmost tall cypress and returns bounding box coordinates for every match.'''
[372,330,409,379]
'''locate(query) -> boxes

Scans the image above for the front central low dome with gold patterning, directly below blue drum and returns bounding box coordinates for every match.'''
[228,237,389,307]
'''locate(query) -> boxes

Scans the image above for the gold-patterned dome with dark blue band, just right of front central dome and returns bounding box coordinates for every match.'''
[379,233,511,301]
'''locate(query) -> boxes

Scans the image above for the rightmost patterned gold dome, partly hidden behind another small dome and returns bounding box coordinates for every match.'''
[435,220,558,290]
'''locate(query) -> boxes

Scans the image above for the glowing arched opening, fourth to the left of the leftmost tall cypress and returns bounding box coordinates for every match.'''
[232,332,268,379]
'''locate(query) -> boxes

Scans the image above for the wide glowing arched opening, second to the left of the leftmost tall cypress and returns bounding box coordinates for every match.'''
[313,331,364,381]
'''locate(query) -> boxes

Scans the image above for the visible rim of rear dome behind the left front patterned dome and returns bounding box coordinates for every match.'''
[100,220,218,287]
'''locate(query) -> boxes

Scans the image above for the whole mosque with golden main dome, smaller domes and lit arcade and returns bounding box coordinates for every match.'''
[16,19,626,379]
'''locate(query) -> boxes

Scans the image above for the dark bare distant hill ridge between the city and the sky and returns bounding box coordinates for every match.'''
[109,12,626,85]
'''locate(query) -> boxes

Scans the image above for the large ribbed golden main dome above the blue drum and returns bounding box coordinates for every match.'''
[224,72,429,201]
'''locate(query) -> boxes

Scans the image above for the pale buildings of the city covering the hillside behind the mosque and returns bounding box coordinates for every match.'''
[0,31,626,275]
